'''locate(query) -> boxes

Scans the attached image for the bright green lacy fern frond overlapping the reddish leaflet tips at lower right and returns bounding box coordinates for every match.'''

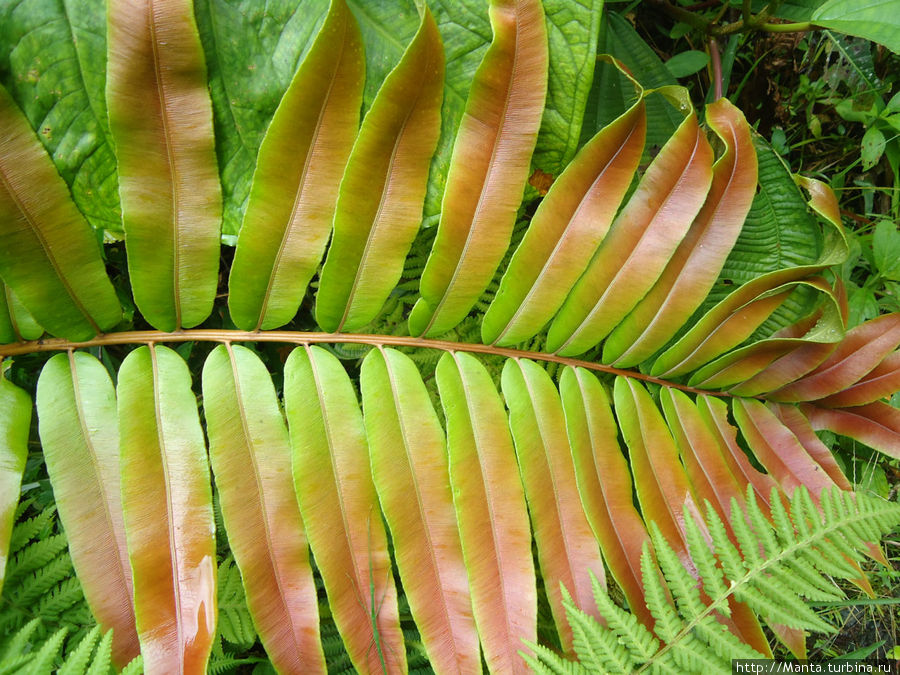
[522,487,900,673]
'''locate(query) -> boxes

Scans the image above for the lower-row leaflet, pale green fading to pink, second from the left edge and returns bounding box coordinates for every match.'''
[36,352,140,667]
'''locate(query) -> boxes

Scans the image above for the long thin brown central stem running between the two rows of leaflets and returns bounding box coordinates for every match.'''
[0,328,730,396]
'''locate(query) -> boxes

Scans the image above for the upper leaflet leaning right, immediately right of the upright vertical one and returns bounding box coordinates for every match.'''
[228,0,365,330]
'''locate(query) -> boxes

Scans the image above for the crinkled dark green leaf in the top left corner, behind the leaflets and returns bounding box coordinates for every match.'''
[0,0,122,233]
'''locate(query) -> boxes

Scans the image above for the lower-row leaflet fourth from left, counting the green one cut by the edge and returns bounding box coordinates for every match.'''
[203,344,325,673]
